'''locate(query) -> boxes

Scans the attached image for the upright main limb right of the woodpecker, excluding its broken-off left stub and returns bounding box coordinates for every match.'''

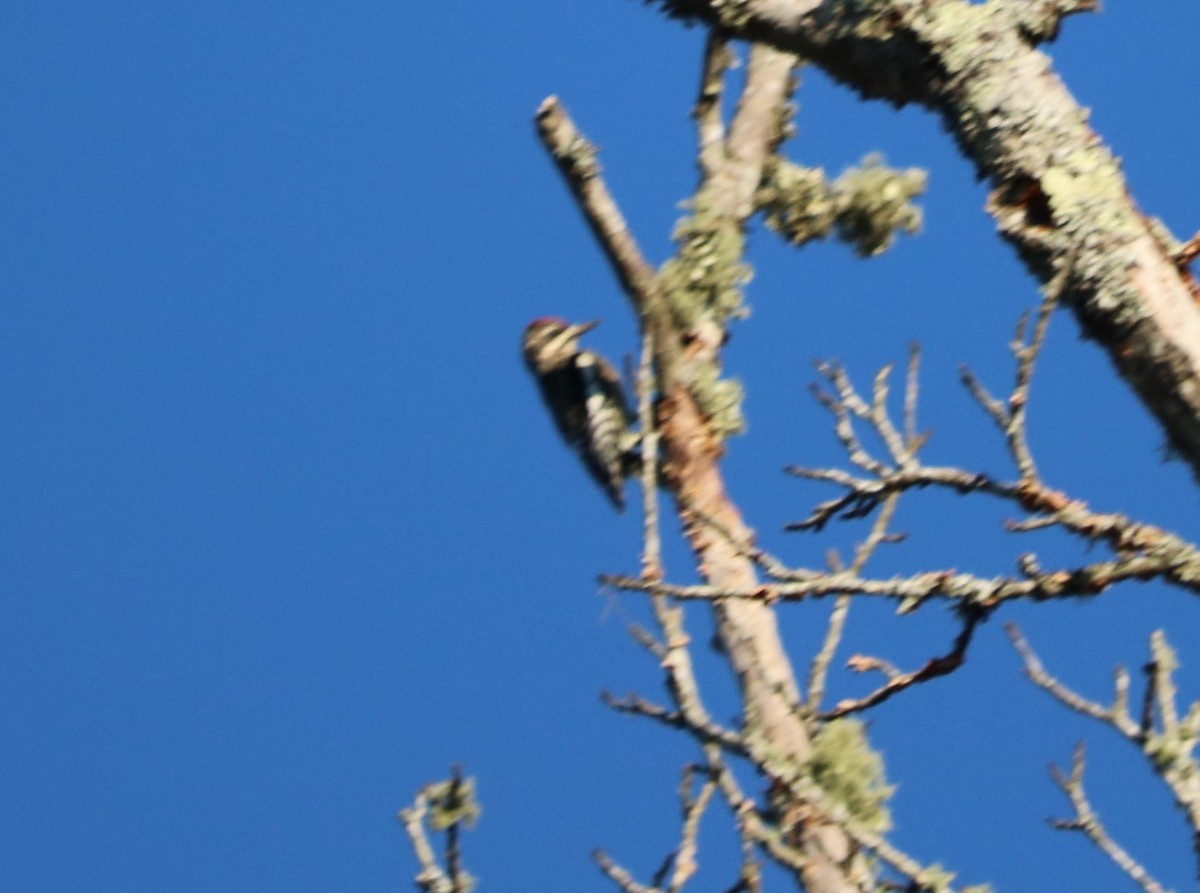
[659,47,873,878]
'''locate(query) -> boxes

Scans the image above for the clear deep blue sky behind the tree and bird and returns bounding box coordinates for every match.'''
[0,0,1200,891]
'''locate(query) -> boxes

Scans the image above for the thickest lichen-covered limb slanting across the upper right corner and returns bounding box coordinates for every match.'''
[658,0,1200,474]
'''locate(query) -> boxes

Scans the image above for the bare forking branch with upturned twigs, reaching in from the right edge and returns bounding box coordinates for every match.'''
[772,336,1200,607]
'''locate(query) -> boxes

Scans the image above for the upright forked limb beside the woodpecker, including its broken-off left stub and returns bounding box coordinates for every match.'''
[538,44,878,893]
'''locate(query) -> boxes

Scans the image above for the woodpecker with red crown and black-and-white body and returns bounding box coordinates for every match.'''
[522,317,636,511]
